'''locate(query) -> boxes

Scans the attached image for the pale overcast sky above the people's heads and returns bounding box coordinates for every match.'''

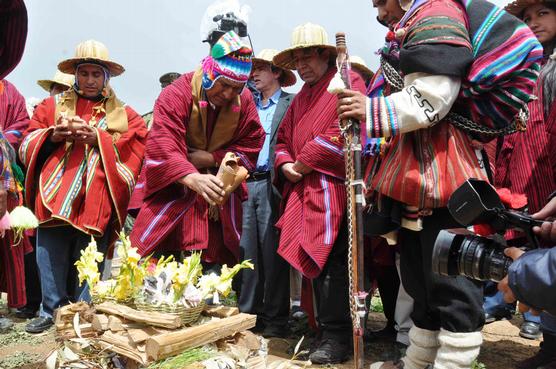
[7,0,505,113]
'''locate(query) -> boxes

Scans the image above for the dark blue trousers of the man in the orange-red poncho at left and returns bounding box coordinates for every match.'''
[36,226,108,317]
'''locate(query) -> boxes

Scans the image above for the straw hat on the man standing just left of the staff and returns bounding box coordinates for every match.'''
[273,23,336,69]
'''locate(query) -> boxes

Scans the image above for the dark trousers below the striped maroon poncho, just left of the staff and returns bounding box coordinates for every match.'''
[313,220,352,343]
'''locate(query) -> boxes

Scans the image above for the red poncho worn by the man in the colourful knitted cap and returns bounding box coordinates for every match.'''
[131,73,264,264]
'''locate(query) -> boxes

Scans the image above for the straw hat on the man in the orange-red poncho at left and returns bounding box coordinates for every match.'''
[58,40,125,77]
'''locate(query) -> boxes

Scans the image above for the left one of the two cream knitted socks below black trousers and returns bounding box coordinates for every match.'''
[370,326,439,369]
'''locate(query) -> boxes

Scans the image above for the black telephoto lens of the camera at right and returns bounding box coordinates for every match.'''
[432,229,512,282]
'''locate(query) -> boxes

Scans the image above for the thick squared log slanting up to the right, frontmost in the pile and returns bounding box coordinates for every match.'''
[146,313,257,360]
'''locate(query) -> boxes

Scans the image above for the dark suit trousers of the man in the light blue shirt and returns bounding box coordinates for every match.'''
[238,179,290,326]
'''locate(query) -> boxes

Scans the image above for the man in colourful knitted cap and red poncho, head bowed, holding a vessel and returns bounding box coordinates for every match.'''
[130,31,264,264]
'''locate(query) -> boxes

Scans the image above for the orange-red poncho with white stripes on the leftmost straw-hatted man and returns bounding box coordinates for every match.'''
[19,91,147,246]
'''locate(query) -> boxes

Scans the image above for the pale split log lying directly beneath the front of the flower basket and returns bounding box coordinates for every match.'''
[96,302,182,329]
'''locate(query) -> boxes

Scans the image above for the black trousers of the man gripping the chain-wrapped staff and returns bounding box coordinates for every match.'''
[400,208,485,332]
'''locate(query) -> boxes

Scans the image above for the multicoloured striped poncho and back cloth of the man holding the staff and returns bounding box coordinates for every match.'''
[367,0,542,209]
